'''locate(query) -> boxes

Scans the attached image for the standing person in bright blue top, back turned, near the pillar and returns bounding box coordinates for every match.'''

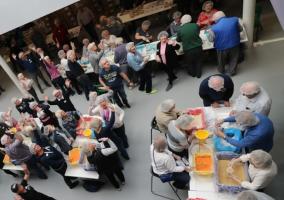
[208,11,242,76]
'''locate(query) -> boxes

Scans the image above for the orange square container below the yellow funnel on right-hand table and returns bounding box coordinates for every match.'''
[194,153,214,175]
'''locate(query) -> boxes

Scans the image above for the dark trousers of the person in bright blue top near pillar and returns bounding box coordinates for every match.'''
[217,45,240,75]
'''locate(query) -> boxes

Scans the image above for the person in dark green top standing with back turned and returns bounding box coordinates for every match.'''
[177,15,202,78]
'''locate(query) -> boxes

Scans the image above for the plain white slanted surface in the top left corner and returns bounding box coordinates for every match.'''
[0,0,78,34]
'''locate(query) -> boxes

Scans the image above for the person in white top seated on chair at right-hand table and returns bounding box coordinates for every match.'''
[150,136,191,190]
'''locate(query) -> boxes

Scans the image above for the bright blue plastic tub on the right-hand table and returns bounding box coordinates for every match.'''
[213,128,242,153]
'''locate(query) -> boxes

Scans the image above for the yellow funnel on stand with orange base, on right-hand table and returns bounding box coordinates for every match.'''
[192,129,213,175]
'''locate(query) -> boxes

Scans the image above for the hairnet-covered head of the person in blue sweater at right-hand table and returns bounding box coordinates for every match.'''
[235,111,259,127]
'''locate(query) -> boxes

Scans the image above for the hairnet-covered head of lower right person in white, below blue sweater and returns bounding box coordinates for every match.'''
[250,149,272,169]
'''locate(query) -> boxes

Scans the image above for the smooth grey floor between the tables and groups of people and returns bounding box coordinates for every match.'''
[0,39,284,200]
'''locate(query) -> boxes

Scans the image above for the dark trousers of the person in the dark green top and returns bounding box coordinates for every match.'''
[184,47,202,78]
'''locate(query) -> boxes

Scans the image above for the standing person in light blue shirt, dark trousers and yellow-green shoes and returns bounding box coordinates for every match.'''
[126,42,157,94]
